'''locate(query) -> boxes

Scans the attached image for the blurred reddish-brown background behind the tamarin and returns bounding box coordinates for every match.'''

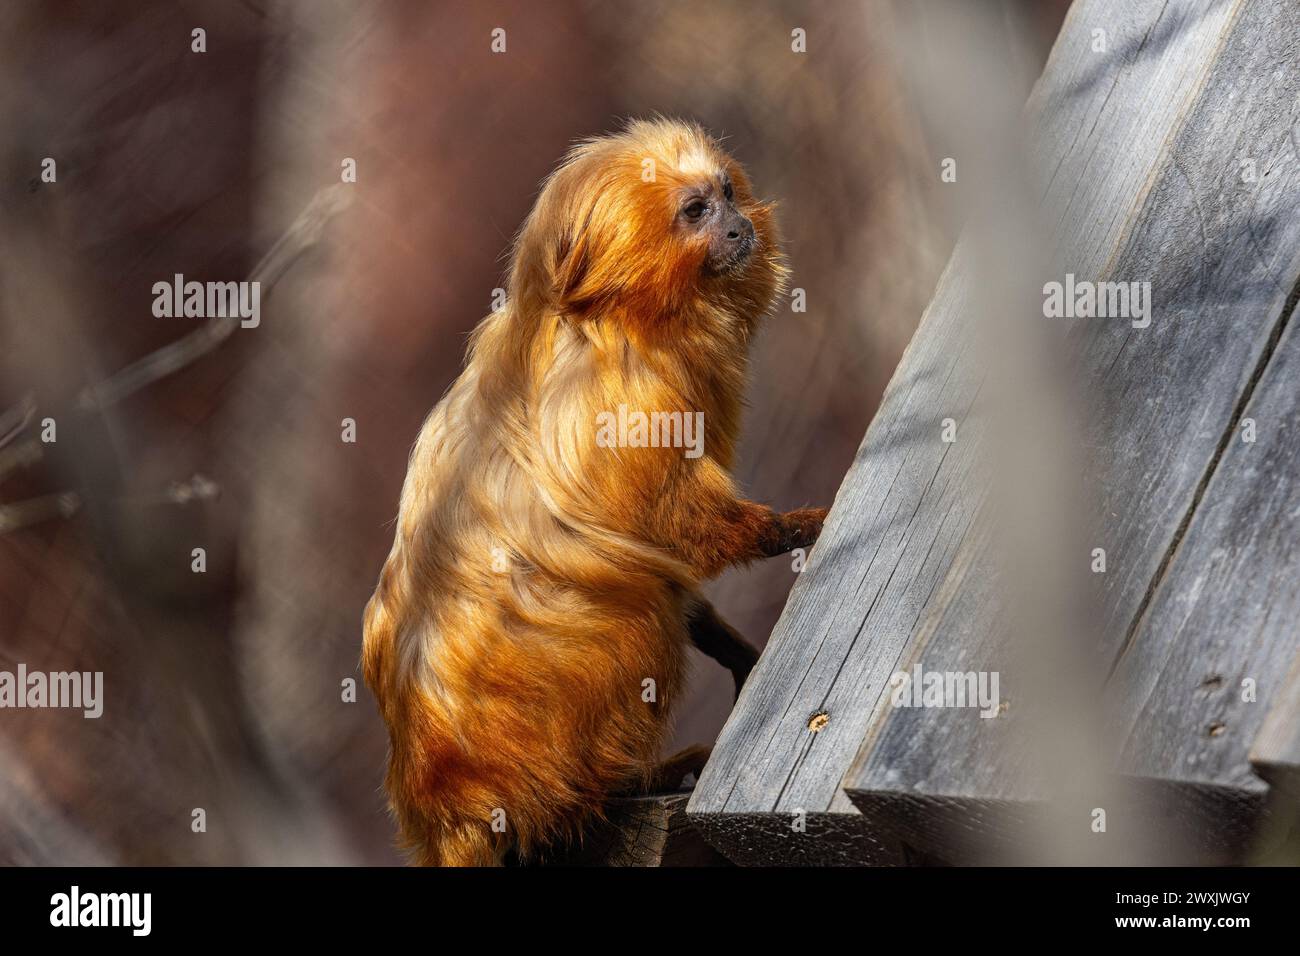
[0,0,1067,864]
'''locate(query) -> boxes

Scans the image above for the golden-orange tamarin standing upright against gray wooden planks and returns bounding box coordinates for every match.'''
[363,120,826,865]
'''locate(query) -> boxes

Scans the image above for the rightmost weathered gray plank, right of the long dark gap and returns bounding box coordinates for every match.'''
[1113,310,1300,862]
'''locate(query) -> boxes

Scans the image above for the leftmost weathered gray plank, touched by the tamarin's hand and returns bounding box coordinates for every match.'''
[690,0,1236,862]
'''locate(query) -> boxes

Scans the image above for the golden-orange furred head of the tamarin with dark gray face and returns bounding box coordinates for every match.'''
[511,118,785,332]
